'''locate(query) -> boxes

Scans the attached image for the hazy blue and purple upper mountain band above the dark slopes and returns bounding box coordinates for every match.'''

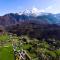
[0,13,60,26]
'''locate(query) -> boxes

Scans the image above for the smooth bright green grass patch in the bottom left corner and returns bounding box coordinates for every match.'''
[0,46,14,60]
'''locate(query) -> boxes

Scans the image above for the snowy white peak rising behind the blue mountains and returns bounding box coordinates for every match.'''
[19,7,45,16]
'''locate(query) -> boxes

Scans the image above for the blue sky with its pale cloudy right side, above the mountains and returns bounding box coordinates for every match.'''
[0,0,60,15]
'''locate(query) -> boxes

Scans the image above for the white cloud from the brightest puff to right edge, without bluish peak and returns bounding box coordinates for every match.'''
[32,5,60,14]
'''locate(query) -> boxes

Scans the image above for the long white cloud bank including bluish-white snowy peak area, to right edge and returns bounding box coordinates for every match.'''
[20,5,60,15]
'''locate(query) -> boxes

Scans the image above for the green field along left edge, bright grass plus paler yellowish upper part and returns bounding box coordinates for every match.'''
[0,34,14,60]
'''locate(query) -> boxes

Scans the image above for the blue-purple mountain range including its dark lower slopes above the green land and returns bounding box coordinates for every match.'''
[0,13,60,39]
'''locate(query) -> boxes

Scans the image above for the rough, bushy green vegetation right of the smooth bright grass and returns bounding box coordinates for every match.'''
[15,36,60,60]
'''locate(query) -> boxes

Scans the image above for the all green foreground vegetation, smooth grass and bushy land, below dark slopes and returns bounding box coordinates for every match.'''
[0,34,60,60]
